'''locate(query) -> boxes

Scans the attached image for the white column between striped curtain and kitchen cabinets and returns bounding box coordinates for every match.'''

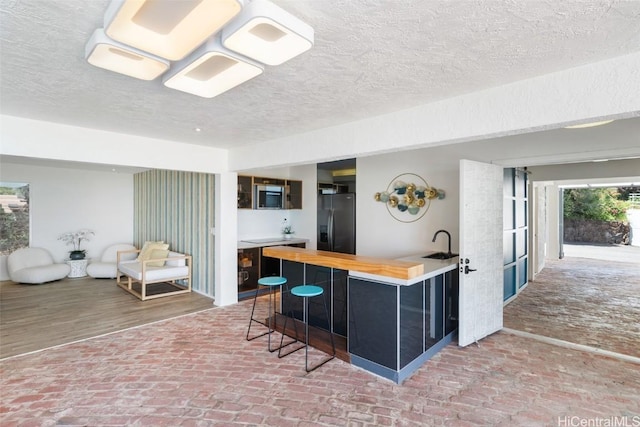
[212,172,238,306]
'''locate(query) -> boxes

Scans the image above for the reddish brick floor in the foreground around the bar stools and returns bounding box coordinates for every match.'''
[0,301,640,427]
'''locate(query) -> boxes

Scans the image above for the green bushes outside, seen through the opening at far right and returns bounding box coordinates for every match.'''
[564,188,629,221]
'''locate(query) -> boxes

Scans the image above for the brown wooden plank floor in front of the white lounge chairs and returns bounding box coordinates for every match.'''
[0,278,213,359]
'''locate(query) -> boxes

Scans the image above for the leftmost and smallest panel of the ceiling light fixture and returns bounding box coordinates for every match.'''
[85,28,169,80]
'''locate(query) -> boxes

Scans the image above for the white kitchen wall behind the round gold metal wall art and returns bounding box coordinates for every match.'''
[356,149,460,258]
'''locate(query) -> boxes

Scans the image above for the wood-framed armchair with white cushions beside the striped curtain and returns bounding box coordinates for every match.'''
[116,249,191,301]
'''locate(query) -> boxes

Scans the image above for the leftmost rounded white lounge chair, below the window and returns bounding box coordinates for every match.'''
[7,248,71,285]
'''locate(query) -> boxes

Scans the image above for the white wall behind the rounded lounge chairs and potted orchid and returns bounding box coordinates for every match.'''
[0,162,133,280]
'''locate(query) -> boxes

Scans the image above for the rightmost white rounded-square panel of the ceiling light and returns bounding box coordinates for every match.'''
[222,0,313,65]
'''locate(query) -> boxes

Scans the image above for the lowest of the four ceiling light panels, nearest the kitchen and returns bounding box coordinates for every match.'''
[162,37,264,98]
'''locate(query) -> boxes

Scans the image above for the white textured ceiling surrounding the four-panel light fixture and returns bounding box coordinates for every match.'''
[0,0,640,148]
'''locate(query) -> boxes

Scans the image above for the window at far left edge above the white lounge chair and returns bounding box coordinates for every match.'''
[0,182,29,255]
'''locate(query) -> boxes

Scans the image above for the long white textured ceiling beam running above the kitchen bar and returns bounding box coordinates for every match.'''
[229,53,640,170]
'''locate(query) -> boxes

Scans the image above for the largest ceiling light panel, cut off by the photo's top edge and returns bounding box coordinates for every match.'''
[104,0,244,61]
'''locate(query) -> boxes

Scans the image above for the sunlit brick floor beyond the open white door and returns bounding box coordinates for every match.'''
[504,258,640,357]
